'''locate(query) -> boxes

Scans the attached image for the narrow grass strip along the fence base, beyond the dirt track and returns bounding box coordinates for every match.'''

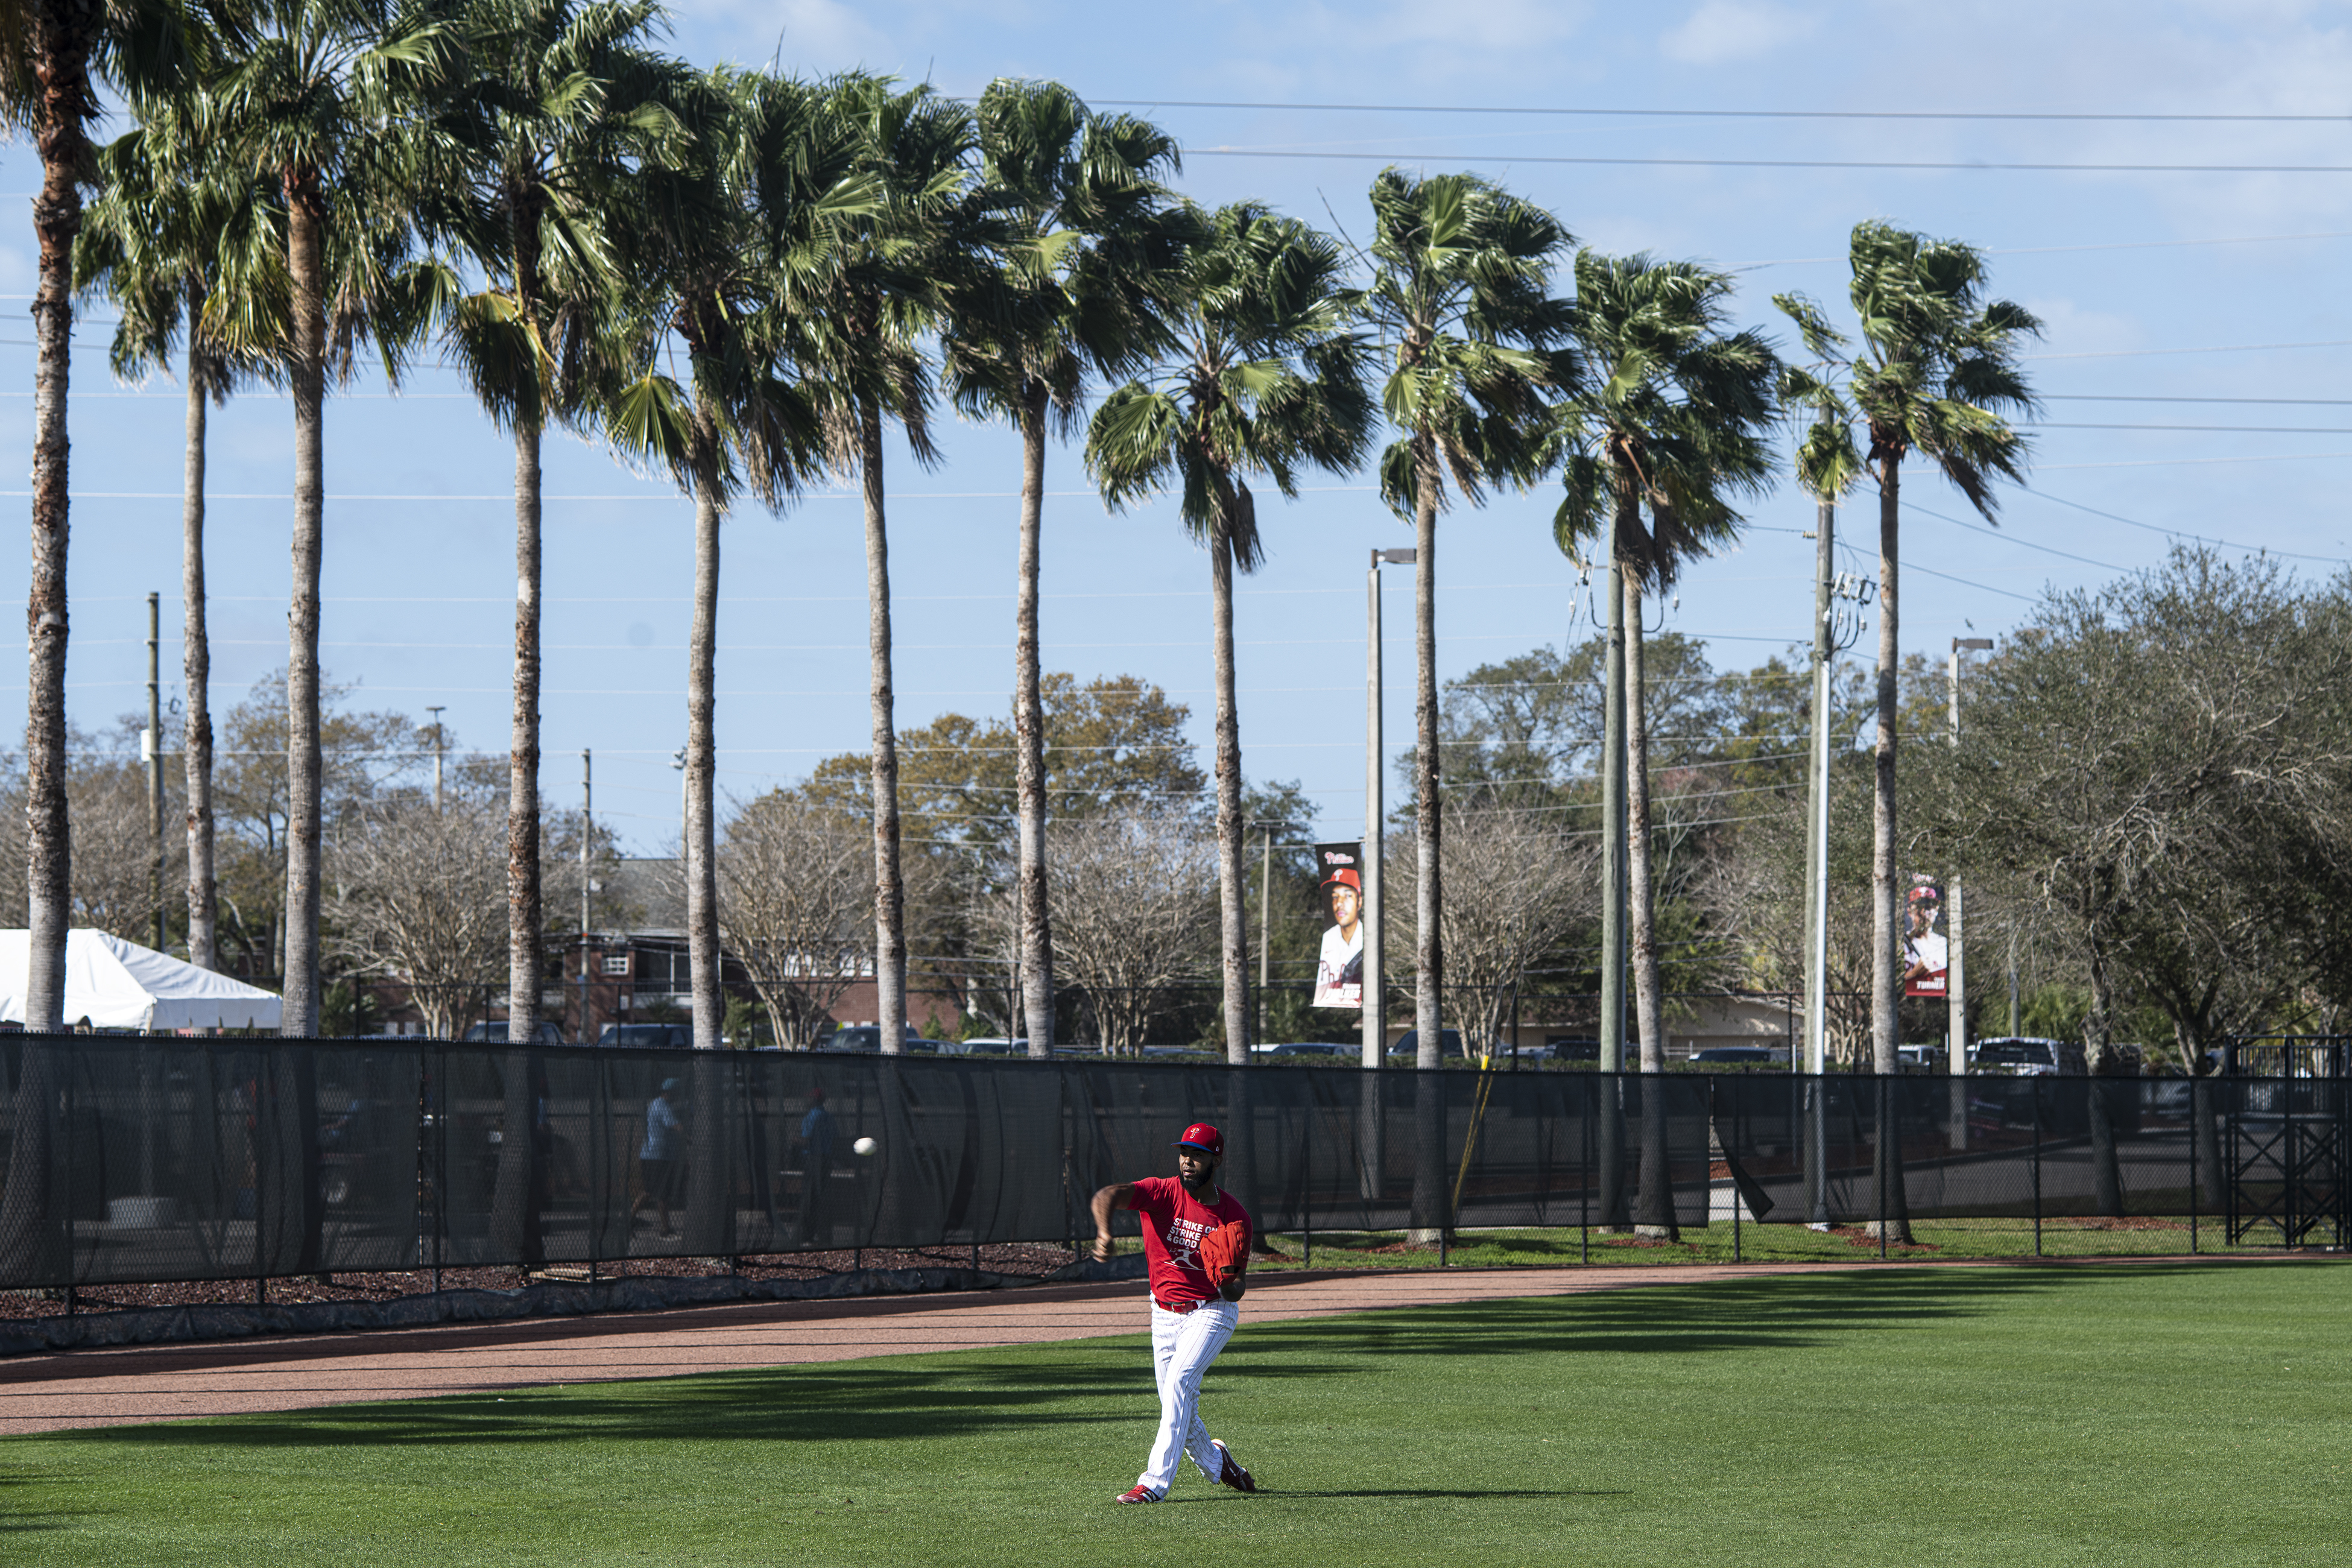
[1251,1218,2279,1269]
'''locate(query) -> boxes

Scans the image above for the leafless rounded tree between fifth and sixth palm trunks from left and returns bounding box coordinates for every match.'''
[718,790,879,1051]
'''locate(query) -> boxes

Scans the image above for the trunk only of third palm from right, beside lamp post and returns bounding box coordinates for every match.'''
[1404,435,1447,1246]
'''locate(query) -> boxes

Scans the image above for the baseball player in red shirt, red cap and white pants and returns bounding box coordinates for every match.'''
[1094,1121,1259,1502]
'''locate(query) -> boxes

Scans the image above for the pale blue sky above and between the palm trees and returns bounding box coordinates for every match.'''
[0,0,2352,851]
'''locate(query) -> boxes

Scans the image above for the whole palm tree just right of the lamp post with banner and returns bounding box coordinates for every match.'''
[1364,169,1576,1244]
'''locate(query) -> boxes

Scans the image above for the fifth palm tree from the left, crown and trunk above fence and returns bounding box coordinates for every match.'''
[607,68,877,1053]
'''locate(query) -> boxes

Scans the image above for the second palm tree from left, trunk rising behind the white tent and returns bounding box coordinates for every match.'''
[73,83,282,969]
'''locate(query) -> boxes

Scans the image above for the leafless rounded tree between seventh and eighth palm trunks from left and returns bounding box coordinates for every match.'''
[1016,806,1216,1055]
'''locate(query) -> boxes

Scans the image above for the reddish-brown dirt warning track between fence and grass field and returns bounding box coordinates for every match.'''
[0,1262,2220,1437]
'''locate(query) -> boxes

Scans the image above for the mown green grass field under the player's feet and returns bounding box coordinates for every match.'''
[0,1262,2352,1568]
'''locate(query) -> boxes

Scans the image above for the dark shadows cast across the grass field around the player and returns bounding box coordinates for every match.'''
[23,1262,2277,1457]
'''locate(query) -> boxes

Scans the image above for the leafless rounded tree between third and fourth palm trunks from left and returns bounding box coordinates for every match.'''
[332,792,506,1039]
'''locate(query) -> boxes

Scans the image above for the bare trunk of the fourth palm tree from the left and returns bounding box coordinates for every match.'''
[489,409,546,1267]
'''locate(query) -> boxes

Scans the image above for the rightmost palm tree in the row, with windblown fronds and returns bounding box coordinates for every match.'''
[1774,219,2041,1241]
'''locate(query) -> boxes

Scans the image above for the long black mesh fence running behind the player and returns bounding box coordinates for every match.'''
[0,1034,2352,1288]
